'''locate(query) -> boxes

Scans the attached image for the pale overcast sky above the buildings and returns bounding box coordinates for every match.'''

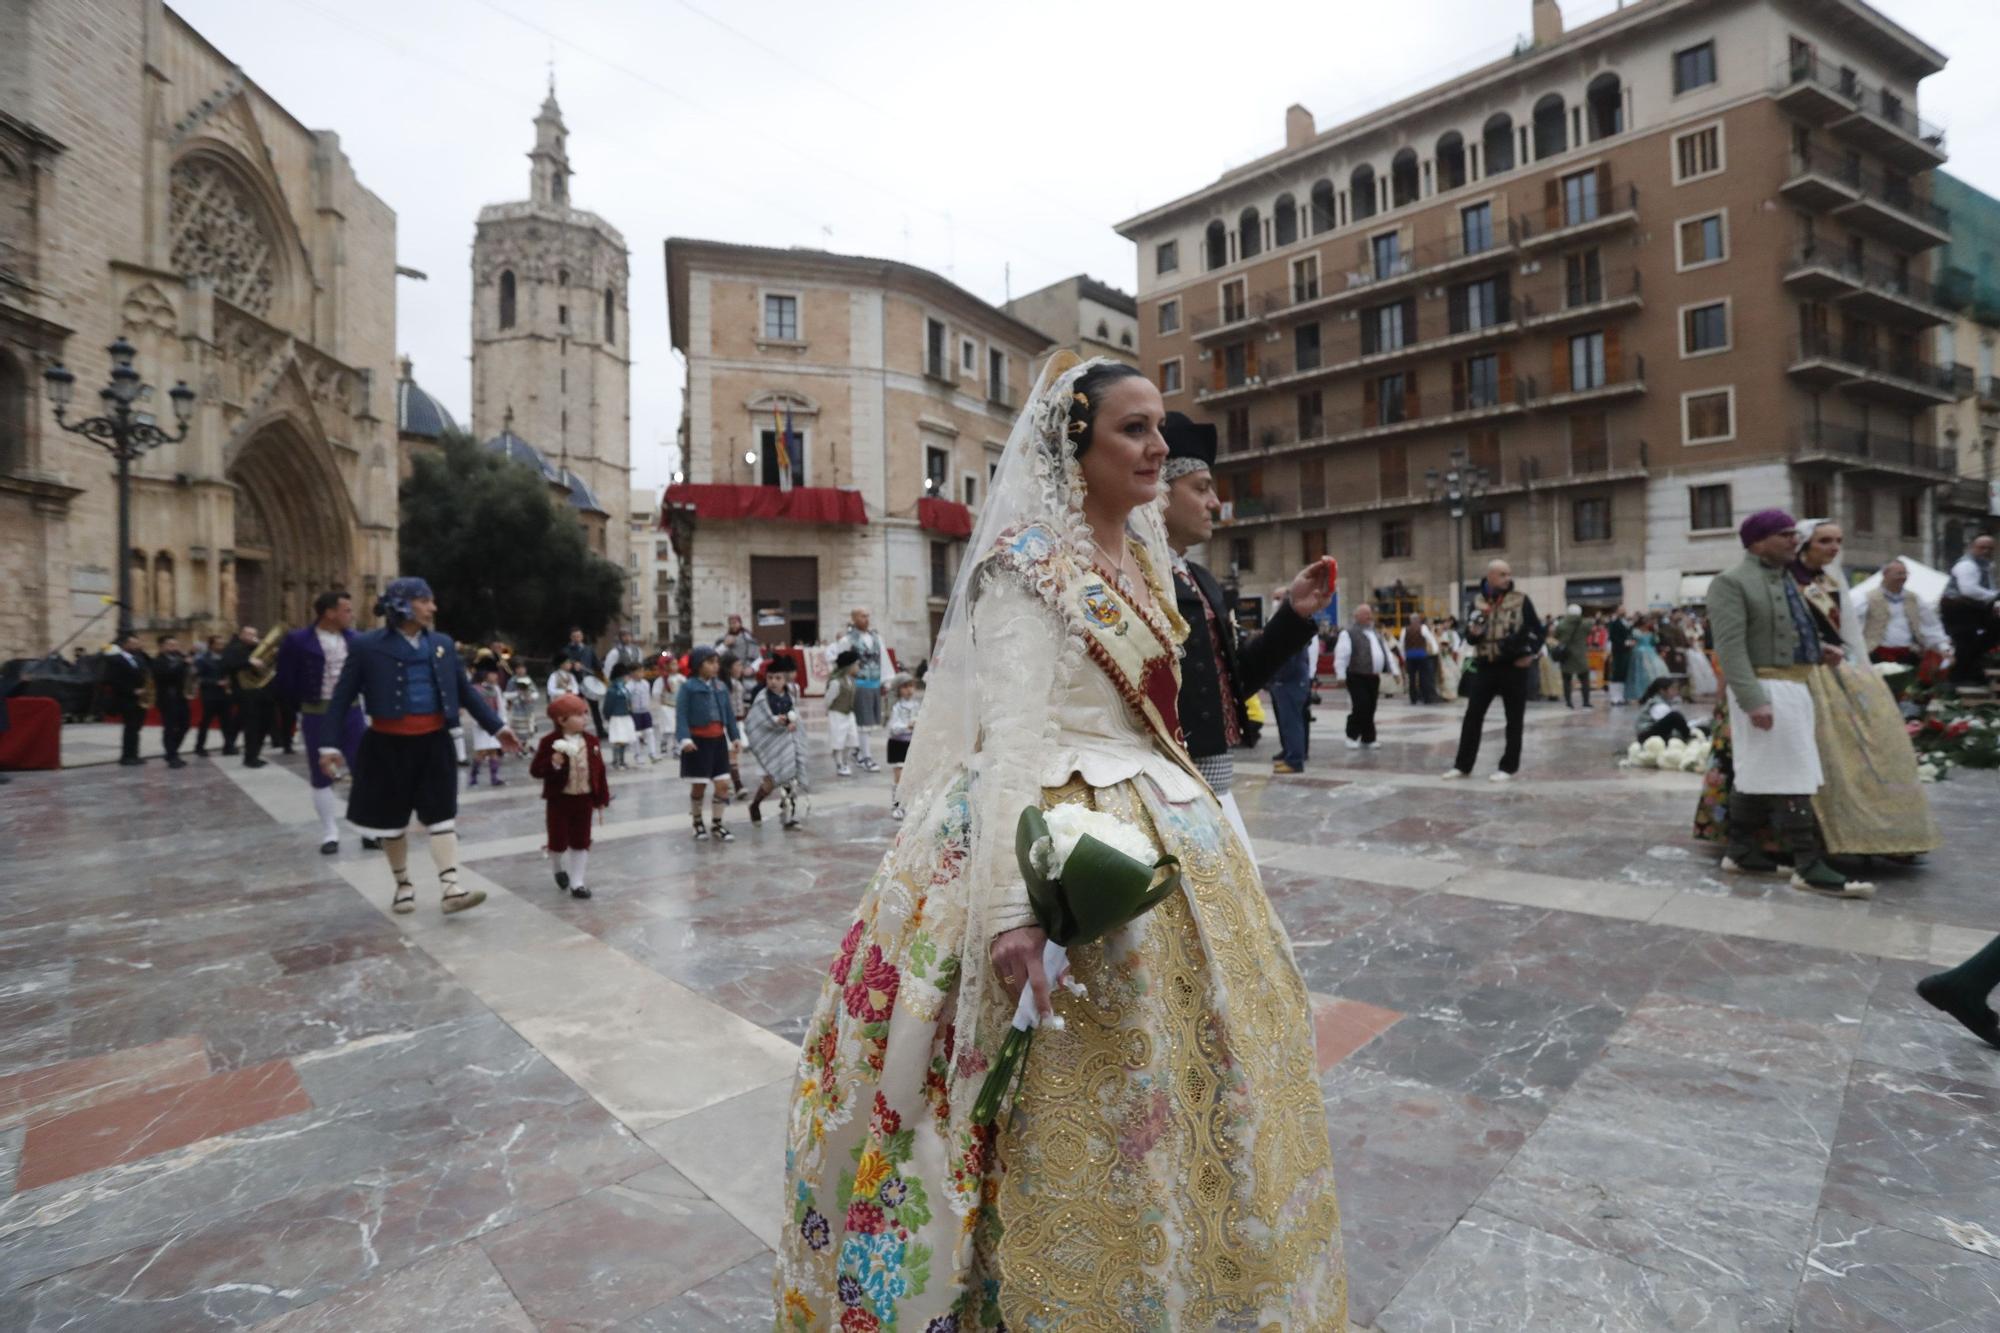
[170,0,2000,484]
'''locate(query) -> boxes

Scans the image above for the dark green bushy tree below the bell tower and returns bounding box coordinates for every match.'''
[398,432,624,650]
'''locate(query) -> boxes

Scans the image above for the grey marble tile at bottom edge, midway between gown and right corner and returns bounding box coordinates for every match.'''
[1376,1209,1790,1333]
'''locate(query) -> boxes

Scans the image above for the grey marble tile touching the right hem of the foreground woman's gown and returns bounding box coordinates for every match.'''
[1322,1061,1538,1323]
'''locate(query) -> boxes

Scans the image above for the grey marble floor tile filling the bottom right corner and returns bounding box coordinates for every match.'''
[1796,1213,2000,1333]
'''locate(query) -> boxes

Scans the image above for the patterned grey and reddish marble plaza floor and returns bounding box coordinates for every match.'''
[0,701,2000,1333]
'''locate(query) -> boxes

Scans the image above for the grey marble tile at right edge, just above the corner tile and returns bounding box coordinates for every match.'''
[1824,1063,2000,1255]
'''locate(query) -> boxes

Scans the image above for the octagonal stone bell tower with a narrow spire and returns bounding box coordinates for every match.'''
[472,88,632,570]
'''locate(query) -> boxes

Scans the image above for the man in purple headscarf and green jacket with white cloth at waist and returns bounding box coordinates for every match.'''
[1708,508,1848,893]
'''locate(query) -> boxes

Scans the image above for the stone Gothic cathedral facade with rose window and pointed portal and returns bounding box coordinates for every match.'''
[0,0,398,660]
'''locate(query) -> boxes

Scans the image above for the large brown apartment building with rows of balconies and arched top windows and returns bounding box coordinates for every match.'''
[1118,0,1970,610]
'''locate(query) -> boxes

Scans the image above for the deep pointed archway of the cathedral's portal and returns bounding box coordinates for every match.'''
[228,418,354,628]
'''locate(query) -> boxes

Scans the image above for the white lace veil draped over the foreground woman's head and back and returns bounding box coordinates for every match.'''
[904,352,1172,1045]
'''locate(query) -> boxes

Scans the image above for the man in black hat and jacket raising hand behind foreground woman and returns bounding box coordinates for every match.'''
[1160,412,1330,847]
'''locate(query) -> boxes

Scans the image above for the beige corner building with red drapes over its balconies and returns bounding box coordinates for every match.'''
[666,238,1050,664]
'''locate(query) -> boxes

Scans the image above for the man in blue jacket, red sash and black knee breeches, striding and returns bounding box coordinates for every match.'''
[320,578,520,913]
